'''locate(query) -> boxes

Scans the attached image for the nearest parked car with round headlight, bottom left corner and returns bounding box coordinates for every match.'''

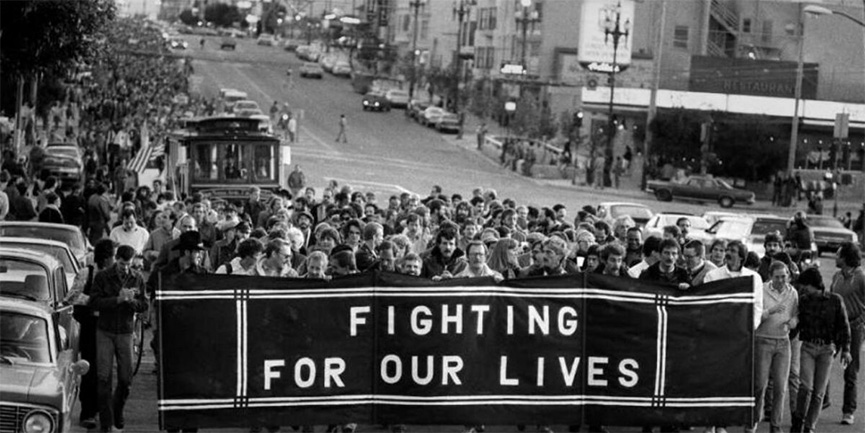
[0,298,90,432]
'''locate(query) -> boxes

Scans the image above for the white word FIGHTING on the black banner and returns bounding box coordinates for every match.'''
[349,304,579,337]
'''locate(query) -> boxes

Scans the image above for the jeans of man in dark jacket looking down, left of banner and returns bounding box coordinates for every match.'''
[96,329,132,430]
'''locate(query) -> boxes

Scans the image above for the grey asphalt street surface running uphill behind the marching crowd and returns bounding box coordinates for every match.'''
[73,36,865,433]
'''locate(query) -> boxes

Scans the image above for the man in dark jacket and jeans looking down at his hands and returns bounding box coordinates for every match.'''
[90,245,147,431]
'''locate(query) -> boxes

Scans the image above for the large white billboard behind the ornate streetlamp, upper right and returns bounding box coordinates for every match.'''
[577,0,634,73]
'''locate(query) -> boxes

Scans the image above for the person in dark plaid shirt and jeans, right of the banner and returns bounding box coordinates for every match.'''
[790,268,853,433]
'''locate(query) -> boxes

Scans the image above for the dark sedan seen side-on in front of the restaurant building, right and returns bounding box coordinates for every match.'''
[646,176,756,208]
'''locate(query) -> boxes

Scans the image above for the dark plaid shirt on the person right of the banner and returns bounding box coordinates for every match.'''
[799,292,850,350]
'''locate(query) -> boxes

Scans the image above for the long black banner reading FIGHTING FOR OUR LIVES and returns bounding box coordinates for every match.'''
[156,273,754,428]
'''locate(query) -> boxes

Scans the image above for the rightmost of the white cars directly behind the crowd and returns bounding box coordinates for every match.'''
[706,215,792,257]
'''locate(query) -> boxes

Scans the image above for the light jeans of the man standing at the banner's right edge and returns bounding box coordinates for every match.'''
[754,337,790,427]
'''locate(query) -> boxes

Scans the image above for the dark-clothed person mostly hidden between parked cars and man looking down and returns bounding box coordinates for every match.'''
[73,239,114,429]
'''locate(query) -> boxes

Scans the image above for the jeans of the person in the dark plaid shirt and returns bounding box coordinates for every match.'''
[793,342,832,430]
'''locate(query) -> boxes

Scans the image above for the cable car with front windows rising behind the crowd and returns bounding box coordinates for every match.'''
[167,116,291,201]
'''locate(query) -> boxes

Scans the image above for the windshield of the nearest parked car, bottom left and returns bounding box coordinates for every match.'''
[0,311,51,363]
